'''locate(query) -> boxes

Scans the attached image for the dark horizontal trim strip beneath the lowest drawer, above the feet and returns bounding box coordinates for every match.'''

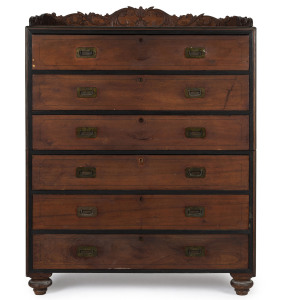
[29,269,252,273]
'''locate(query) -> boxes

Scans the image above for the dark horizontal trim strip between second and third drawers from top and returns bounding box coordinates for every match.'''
[32,110,249,116]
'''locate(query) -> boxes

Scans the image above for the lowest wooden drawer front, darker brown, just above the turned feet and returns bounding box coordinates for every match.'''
[33,234,248,270]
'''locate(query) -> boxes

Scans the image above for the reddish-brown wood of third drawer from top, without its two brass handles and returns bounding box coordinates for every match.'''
[33,115,249,150]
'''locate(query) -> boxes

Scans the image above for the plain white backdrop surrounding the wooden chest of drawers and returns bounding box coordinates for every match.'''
[0,0,284,300]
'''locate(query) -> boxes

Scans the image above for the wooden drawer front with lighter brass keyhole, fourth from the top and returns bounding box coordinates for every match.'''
[32,155,249,190]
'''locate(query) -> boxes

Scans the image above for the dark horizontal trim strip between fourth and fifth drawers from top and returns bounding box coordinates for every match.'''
[31,190,249,195]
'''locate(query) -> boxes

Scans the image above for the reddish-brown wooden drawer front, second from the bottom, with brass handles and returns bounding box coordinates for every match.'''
[33,195,249,230]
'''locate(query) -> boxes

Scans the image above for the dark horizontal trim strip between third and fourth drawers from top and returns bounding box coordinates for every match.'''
[31,150,250,155]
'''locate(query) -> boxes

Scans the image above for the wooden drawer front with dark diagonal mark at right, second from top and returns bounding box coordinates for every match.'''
[33,75,249,110]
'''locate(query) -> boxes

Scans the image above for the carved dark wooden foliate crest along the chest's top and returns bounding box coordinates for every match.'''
[30,6,253,27]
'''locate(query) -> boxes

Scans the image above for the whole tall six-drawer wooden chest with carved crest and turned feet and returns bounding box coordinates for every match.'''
[26,7,255,295]
